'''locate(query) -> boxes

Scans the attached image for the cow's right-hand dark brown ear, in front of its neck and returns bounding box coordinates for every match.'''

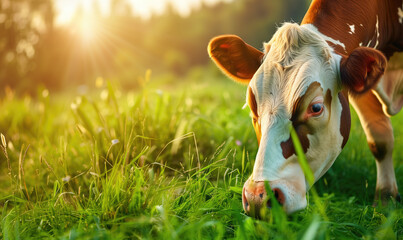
[340,47,386,94]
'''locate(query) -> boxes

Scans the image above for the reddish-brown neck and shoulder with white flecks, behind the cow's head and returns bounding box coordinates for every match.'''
[302,0,403,58]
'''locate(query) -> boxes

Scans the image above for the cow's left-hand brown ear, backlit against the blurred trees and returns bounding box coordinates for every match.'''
[208,35,263,84]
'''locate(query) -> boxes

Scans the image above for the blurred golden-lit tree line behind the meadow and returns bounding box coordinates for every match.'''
[0,0,308,93]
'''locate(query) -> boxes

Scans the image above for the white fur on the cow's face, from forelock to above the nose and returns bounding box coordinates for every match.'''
[245,25,343,212]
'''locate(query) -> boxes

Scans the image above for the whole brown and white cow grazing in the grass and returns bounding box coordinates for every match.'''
[208,0,403,215]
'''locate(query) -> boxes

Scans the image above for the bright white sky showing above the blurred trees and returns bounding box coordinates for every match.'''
[55,0,232,25]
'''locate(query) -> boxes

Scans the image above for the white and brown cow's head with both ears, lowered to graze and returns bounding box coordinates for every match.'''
[208,23,386,215]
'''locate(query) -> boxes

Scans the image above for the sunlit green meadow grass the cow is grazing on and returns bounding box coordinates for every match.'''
[0,69,403,239]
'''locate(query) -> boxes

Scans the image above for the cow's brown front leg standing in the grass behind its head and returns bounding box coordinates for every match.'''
[350,92,400,204]
